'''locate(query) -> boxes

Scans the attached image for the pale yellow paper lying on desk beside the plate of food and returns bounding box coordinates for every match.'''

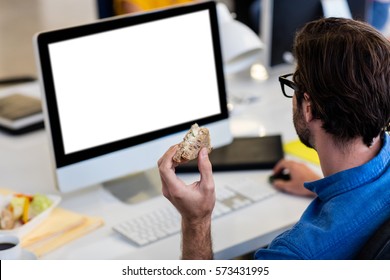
[22,208,104,257]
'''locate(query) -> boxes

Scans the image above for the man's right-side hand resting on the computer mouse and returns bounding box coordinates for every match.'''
[273,159,321,196]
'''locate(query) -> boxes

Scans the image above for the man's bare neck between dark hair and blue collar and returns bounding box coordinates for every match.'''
[315,131,382,176]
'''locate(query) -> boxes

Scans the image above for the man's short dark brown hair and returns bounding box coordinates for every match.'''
[293,18,390,146]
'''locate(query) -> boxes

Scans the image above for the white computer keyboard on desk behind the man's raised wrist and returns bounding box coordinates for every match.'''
[113,179,277,246]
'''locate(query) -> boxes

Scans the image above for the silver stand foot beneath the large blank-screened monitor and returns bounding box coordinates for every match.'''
[103,168,162,204]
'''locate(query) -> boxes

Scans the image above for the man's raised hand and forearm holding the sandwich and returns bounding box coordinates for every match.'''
[158,145,215,259]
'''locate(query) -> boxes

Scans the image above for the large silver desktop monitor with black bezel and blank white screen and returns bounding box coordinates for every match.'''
[34,2,232,195]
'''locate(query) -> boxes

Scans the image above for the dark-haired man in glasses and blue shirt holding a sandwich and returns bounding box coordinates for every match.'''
[158,18,390,259]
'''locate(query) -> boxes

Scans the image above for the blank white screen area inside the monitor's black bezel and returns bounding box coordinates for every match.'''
[49,11,220,154]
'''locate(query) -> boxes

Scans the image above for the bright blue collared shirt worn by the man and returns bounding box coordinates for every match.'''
[255,133,390,260]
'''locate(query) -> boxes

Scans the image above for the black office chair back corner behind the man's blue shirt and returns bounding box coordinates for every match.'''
[355,219,390,260]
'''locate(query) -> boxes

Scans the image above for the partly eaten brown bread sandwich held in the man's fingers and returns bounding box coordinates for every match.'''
[173,123,213,163]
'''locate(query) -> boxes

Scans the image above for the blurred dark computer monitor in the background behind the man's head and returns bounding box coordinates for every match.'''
[260,0,368,72]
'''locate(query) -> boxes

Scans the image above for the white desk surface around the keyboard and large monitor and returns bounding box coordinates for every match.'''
[0,69,316,259]
